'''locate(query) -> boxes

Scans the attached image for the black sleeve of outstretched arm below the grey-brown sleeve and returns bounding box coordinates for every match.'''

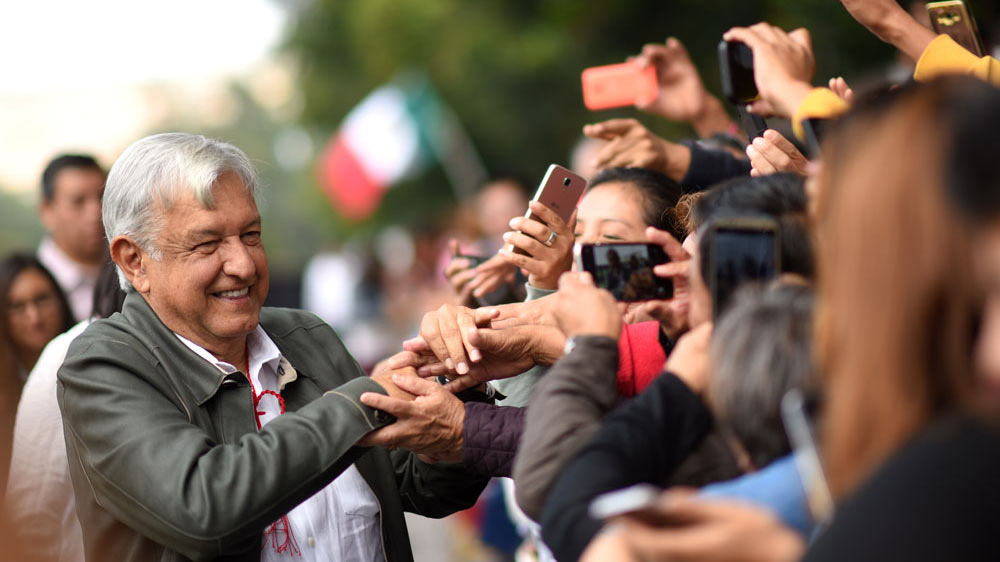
[541,373,712,562]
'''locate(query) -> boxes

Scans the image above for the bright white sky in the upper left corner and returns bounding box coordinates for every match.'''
[0,0,287,195]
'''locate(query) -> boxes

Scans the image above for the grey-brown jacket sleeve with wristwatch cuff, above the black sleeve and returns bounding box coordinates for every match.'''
[513,337,618,520]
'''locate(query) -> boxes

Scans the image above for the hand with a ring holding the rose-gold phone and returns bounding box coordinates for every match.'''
[500,201,576,290]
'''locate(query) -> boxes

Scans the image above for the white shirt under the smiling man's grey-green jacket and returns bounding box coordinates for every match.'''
[175,326,385,562]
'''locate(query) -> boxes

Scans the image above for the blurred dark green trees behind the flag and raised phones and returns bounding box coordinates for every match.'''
[286,0,893,227]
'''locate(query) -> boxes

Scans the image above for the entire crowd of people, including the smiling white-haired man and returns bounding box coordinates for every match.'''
[0,0,1000,562]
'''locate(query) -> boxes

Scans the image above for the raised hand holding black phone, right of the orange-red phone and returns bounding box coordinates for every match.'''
[722,23,816,118]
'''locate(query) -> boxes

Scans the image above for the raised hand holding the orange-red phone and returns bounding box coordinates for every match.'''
[630,37,732,138]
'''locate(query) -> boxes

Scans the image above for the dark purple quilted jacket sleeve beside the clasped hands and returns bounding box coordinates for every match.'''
[462,402,525,476]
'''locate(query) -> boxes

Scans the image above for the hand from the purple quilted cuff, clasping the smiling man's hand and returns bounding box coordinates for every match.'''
[358,371,465,462]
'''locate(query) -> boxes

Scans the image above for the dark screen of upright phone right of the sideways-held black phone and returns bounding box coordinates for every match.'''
[712,228,778,318]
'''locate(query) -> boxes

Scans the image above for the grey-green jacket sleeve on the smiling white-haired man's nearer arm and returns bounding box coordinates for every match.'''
[58,334,388,560]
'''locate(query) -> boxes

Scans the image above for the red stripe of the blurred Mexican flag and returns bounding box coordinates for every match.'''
[316,135,385,221]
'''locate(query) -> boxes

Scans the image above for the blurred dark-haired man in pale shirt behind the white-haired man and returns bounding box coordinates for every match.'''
[38,154,109,320]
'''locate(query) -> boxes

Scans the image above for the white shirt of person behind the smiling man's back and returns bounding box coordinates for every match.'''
[4,320,90,562]
